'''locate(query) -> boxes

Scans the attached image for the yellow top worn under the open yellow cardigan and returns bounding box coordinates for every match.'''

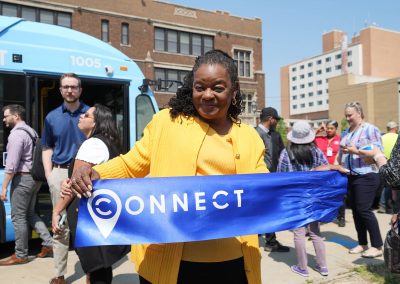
[182,127,243,262]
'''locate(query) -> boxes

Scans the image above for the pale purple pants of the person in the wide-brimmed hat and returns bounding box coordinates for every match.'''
[293,222,327,269]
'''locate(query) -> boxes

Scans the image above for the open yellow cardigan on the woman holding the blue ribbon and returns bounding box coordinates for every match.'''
[94,109,268,284]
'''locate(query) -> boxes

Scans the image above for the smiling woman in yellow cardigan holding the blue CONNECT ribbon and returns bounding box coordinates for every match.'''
[72,50,268,284]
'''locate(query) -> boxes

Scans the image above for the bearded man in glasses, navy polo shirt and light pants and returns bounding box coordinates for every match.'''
[42,73,89,284]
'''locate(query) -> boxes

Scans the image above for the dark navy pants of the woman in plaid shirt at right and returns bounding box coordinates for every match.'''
[347,173,383,248]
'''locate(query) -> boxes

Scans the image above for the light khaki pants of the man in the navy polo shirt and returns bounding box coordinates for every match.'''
[47,168,69,277]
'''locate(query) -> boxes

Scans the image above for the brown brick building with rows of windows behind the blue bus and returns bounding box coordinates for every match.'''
[0,0,265,124]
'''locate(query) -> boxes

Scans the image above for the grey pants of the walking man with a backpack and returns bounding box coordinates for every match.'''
[10,175,53,258]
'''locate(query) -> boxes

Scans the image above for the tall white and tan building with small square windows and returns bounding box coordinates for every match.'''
[281,26,400,126]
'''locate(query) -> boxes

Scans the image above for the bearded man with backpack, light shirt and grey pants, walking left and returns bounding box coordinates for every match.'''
[0,105,53,266]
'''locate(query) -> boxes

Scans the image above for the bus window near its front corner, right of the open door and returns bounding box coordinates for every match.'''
[136,95,155,140]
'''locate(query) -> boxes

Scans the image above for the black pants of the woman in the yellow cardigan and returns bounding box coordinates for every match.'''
[139,257,247,284]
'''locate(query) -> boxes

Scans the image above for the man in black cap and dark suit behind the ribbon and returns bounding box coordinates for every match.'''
[256,107,289,252]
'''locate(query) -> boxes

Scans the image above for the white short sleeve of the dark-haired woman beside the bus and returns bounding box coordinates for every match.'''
[75,137,110,165]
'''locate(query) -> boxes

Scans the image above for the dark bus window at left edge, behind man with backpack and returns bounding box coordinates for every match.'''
[0,74,26,167]
